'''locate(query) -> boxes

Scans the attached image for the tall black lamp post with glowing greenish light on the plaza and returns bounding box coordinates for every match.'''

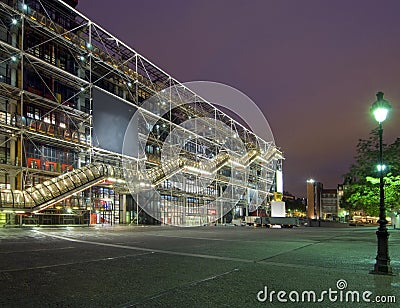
[371,92,392,275]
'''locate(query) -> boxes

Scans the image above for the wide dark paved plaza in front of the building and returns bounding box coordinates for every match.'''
[0,226,400,307]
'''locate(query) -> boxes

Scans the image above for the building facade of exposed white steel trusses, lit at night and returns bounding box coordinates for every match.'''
[0,0,283,225]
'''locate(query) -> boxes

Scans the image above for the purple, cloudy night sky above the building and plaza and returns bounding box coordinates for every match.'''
[77,0,400,197]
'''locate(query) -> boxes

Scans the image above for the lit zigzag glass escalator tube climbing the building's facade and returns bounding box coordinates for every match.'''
[0,150,270,213]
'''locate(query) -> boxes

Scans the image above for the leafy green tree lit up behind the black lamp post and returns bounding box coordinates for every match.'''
[341,129,400,216]
